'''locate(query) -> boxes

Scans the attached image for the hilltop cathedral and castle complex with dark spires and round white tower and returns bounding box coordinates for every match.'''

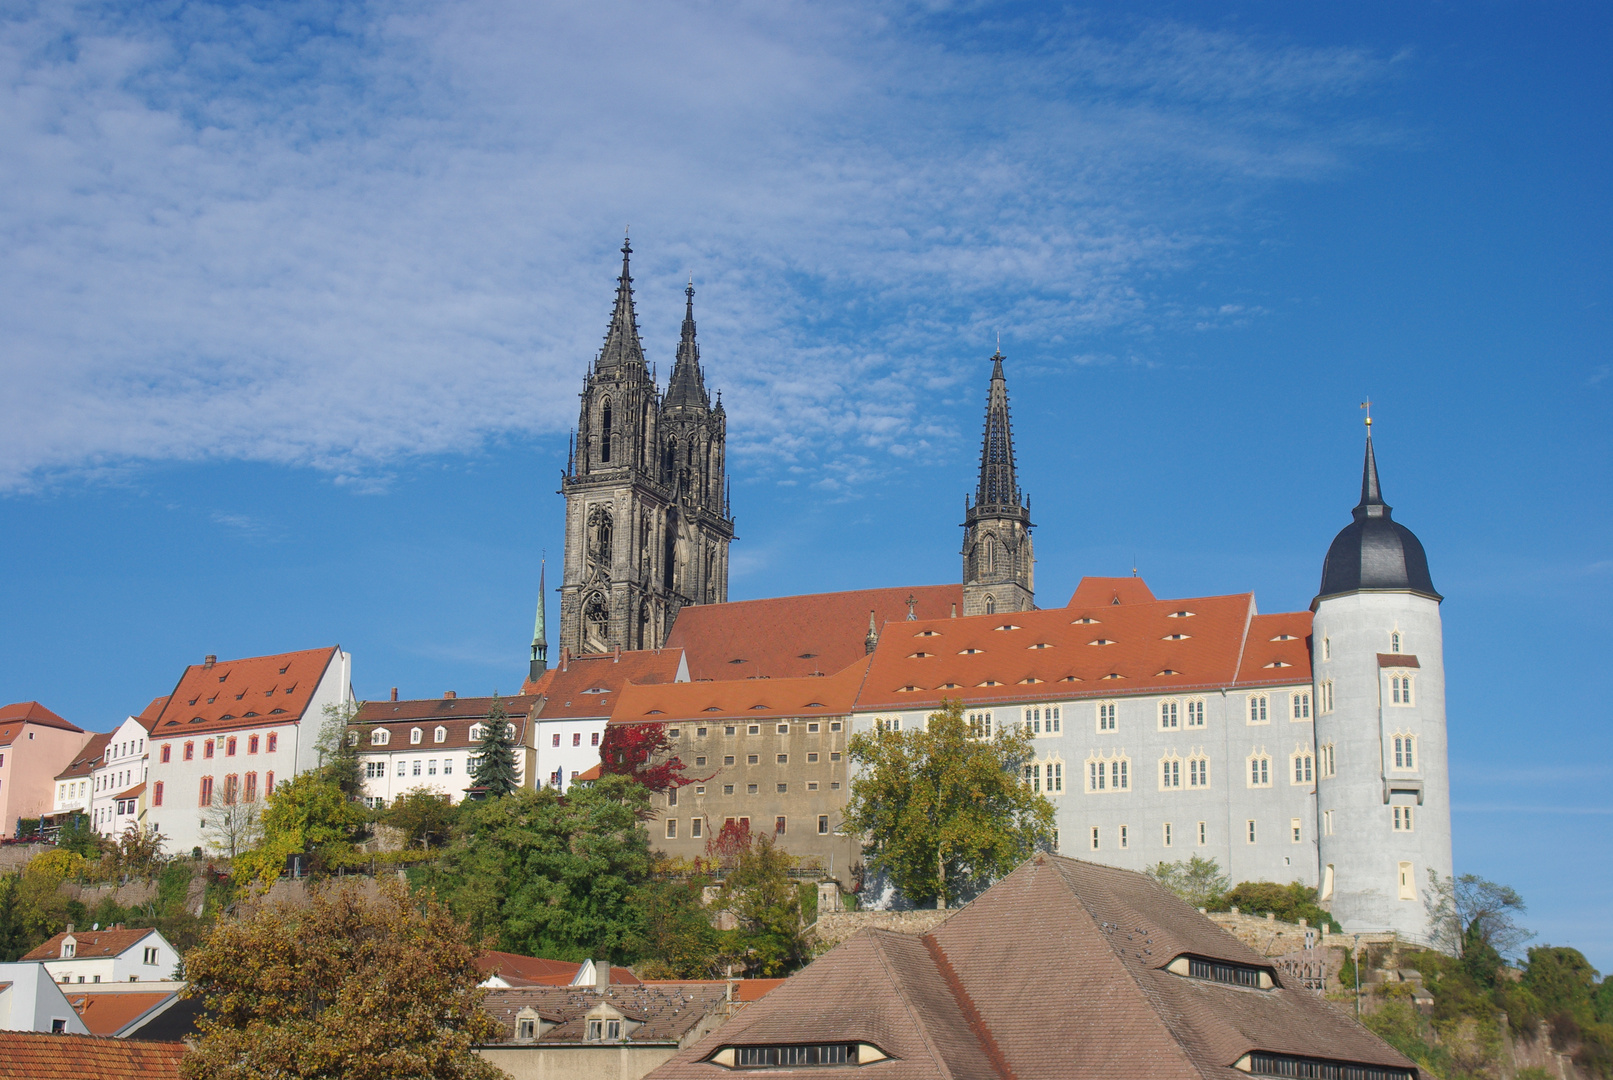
[523,243,1452,940]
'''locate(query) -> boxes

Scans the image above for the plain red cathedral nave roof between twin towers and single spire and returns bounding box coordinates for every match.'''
[664,585,963,682]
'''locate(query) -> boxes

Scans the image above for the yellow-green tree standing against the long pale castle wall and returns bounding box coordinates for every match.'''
[845,700,1053,908]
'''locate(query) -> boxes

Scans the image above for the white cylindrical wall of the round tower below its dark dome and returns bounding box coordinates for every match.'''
[1313,593,1452,937]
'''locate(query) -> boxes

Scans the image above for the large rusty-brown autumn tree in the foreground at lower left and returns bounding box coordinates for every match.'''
[181,882,503,1080]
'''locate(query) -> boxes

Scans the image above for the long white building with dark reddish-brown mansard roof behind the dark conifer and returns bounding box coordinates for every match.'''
[347,690,540,808]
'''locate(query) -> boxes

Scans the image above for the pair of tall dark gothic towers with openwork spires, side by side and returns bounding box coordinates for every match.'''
[560,242,734,653]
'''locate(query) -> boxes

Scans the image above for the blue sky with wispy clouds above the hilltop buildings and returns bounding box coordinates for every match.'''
[0,0,1613,970]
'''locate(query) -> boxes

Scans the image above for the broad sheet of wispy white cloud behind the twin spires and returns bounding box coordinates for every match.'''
[0,0,1392,490]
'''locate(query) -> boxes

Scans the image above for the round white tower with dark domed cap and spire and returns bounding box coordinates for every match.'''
[1311,419,1452,940]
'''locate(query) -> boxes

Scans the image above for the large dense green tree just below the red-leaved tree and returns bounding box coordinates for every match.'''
[437,777,650,962]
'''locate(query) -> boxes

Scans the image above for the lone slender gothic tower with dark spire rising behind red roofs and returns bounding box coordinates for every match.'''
[963,351,1036,616]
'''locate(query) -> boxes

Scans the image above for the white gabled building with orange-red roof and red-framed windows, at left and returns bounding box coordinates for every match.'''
[142,645,356,853]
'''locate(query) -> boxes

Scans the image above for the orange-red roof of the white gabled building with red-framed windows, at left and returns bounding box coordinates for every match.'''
[142,645,336,738]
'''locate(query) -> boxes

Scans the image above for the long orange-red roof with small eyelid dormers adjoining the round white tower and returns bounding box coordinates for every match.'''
[857,577,1310,709]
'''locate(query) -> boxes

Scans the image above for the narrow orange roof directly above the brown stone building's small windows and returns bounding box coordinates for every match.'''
[611,654,877,724]
